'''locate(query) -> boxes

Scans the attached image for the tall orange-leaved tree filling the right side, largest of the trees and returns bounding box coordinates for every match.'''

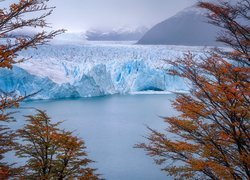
[136,0,250,179]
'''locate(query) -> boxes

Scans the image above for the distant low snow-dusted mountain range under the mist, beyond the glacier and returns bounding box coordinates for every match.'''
[85,27,148,41]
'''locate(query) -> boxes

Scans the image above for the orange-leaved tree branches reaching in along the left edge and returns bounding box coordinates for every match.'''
[0,0,64,178]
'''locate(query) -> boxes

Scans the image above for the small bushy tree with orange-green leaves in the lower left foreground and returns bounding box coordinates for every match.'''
[16,110,98,180]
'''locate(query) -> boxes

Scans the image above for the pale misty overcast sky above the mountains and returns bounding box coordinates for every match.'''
[0,0,196,32]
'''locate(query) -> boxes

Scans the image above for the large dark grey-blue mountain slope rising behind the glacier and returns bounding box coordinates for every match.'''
[138,7,223,46]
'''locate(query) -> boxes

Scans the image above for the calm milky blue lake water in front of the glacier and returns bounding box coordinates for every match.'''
[9,95,177,180]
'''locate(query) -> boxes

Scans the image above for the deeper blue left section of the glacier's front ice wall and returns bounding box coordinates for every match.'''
[0,66,79,99]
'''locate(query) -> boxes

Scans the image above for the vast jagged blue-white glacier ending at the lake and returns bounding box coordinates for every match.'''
[0,42,204,99]
